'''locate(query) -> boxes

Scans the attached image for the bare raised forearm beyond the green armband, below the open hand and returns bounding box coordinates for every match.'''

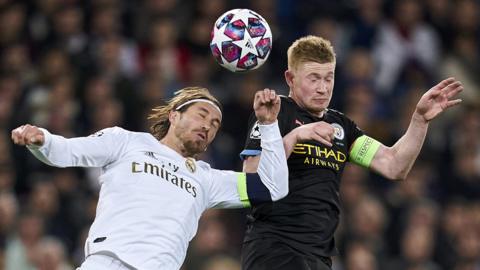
[389,113,428,179]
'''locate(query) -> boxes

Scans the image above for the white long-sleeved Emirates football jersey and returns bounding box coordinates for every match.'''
[29,124,288,270]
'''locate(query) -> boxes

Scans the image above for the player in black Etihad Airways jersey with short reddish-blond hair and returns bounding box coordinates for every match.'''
[241,36,463,270]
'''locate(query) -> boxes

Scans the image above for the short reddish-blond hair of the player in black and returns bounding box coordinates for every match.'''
[287,35,336,70]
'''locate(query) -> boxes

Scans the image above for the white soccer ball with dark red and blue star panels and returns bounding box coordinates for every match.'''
[210,9,272,72]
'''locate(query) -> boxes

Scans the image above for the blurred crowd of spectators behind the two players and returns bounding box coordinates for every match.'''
[0,0,480,270]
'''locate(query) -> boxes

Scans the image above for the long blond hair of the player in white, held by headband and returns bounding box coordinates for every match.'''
[148,86,221,140]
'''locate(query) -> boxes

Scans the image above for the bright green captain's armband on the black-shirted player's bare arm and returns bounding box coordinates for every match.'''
[349,135,380,168]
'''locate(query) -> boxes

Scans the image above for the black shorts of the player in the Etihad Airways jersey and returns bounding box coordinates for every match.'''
[242,238,332,270]
